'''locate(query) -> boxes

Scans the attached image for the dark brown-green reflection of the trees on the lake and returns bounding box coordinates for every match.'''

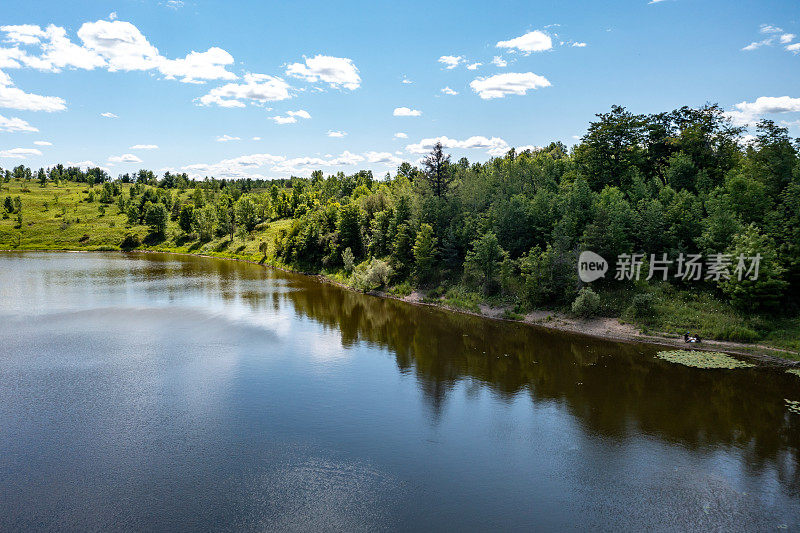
[276,262,800,490]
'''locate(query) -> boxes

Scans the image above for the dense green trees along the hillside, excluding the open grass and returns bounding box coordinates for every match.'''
[5,105,800,312]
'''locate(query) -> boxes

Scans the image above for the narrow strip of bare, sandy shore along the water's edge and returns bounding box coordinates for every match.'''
[6,248,800,369]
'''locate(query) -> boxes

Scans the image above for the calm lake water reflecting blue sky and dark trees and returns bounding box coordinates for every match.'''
[0,253,800,531]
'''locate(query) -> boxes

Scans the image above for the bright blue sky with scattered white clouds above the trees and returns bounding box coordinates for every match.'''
[0,0,800,177]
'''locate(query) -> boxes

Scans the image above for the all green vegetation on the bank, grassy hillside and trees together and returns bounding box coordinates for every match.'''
[0,106,800,351]
